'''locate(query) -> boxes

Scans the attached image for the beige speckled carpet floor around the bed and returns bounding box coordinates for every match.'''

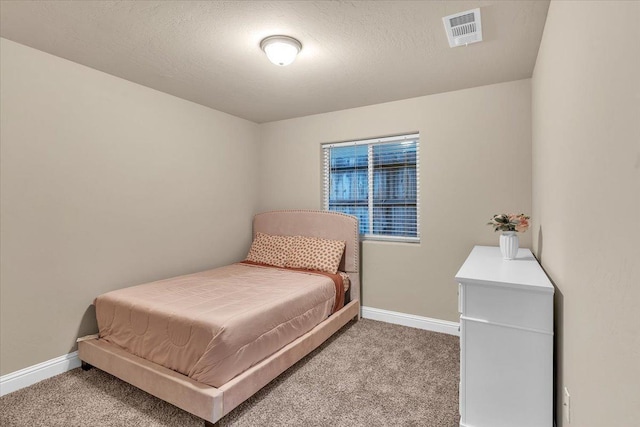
[0,319,459,427]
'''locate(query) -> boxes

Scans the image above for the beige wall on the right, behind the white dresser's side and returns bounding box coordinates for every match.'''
[532,1,640,427]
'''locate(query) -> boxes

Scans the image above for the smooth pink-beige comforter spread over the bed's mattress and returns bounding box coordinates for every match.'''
[95,264,336,387]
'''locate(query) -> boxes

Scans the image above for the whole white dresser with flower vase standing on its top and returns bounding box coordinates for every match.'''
[456,246,553,427]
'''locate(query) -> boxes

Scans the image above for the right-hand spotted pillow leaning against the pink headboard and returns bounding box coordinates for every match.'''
[285,236,346,274]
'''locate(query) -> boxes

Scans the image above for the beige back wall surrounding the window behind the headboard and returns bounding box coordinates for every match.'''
[259,80,531,321]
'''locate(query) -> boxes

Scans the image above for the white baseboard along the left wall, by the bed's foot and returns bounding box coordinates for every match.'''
[0,351,80,396]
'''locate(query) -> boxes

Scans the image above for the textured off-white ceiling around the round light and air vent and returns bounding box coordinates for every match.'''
[0,0,549,123]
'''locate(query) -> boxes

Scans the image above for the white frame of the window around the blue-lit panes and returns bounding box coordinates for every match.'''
[320,132,420,243]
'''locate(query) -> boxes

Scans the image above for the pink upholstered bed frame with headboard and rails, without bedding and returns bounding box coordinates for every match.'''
[78,210,360,426]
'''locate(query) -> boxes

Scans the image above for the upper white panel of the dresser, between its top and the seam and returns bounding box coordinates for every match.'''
[461,284,553,333]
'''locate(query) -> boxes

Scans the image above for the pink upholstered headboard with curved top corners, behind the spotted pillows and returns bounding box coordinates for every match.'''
[253,210,360,300]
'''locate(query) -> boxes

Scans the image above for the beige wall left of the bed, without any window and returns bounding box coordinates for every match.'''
[0,39,258,374]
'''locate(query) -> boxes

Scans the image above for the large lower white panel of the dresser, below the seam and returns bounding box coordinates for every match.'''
[460,320,553,427]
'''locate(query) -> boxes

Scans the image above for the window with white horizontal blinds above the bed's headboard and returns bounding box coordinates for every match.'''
[322,134,420,242]
